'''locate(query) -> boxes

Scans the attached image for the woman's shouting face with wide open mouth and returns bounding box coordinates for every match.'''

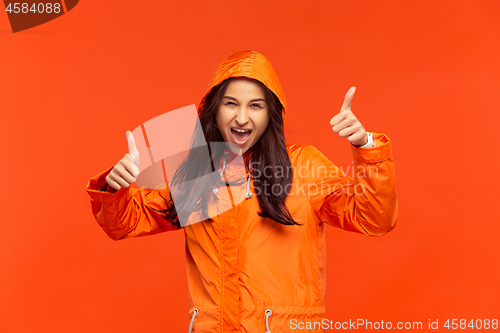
[215,77,269,154]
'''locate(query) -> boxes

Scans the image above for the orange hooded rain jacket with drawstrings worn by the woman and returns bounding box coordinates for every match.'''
[86,51,398,333]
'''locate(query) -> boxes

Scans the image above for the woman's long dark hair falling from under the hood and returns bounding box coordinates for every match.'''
[158,78,300,226]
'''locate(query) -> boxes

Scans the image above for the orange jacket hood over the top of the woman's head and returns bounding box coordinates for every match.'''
[198,50,287,123]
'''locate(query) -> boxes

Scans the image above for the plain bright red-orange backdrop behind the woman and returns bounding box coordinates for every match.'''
[0,0,500,333]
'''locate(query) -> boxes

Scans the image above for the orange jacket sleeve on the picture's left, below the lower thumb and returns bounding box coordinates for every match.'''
[85,167,180,240]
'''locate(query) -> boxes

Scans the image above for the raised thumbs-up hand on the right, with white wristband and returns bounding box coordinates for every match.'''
[330,87,368,147]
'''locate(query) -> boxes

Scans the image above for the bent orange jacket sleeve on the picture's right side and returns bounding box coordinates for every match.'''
[302,132,398,236]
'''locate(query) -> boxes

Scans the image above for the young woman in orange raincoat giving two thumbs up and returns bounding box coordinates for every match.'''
[86,51,397,333]
